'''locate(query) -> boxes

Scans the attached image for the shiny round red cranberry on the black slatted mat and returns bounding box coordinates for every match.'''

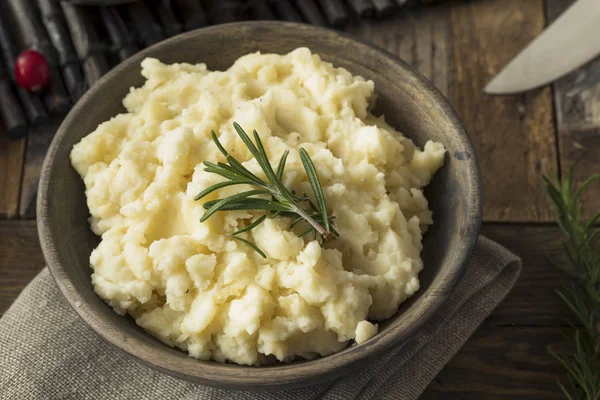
[15,50,51,92]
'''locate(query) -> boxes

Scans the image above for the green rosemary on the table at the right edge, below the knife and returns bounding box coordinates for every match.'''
[544,166,600,400]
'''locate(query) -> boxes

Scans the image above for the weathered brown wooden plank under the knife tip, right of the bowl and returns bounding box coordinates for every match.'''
[450,0,558,222]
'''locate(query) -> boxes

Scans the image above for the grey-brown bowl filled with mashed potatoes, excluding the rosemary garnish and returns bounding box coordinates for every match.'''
[38,22,481,390]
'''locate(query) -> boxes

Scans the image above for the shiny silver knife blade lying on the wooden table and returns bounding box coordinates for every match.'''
[483,0,600,94]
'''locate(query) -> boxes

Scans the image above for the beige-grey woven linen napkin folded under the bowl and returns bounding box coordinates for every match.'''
[0,237,521,400]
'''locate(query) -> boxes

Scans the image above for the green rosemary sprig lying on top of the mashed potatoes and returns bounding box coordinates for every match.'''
[194,122,338,258]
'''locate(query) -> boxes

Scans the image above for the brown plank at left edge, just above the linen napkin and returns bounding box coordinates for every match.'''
[0,221,44,315]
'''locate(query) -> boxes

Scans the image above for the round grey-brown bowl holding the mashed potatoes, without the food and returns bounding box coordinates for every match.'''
[37,22,481,390]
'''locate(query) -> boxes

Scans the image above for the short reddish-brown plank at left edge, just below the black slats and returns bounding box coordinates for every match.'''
[0,126,26,219]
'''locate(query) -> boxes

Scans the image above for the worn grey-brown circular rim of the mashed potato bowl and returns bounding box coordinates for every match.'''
[37,21,483,390]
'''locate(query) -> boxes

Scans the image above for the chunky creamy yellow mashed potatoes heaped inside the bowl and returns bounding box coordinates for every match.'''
[71,48,445,365]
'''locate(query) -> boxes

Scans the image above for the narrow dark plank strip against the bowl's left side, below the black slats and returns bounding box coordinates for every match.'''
[19,118,62,219]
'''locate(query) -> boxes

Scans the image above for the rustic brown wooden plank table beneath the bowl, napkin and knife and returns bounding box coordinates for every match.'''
[0,0,600,399]
